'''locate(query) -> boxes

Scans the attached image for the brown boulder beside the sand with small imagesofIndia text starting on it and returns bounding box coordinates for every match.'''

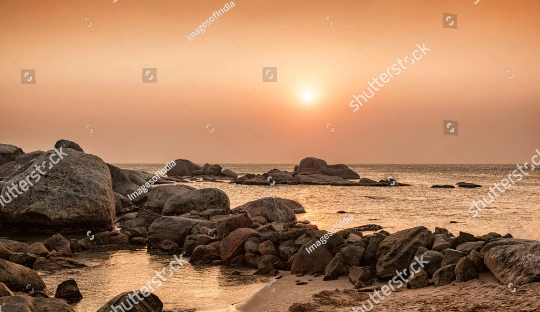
[289,238,334,274]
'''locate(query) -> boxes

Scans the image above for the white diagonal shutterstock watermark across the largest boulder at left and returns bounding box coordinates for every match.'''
[0,147,69,207]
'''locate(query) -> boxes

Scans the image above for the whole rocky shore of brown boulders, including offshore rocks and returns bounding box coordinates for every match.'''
[0,140,540,312]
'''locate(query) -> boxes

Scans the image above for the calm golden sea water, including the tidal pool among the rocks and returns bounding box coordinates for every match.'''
[22,164,540,312]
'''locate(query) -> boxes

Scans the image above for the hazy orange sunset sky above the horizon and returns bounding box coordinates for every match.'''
[0,0,540,164]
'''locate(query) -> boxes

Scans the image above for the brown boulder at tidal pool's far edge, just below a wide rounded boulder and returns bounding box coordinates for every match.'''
[148,216,200,248]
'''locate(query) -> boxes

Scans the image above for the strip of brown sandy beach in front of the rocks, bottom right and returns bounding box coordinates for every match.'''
[236,272,540,312]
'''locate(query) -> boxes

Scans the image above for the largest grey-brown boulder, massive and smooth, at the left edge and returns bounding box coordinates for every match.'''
[0,149,115,232]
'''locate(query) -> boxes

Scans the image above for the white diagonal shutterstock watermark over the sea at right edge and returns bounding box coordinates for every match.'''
[468,149,540,218]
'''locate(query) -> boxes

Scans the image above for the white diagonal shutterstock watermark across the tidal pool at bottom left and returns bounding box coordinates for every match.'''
[110,255,188,312]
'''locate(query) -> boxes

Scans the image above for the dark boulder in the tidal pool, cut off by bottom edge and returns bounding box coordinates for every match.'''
[97,287,163,312]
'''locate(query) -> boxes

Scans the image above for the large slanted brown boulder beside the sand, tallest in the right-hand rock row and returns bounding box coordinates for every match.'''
[376,226,432,278]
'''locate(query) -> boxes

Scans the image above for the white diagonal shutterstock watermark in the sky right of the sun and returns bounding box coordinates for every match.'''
[349,42,431,113]
